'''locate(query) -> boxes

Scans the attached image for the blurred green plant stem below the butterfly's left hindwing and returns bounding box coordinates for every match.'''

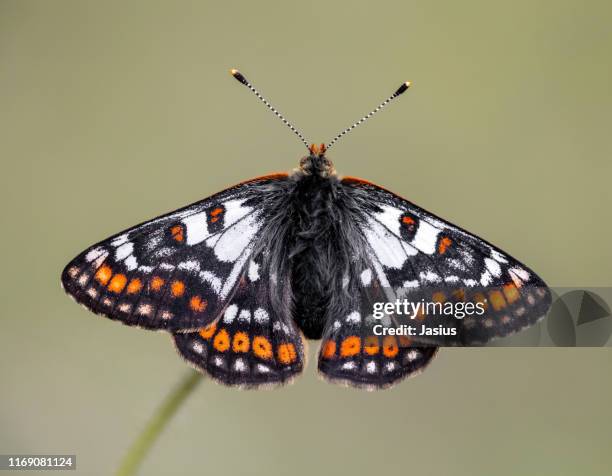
[116,370,202,476]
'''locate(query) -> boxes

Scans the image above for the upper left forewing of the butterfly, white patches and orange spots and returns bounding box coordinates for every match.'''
[62,174,287,331]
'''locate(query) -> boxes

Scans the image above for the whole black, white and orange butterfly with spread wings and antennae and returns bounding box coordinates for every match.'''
[61,70,551,389]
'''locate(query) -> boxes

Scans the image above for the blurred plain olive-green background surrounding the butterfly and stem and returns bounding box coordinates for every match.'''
[0,0,612,475]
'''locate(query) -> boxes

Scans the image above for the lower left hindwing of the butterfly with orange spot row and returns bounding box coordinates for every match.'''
[174,251,305,388]
